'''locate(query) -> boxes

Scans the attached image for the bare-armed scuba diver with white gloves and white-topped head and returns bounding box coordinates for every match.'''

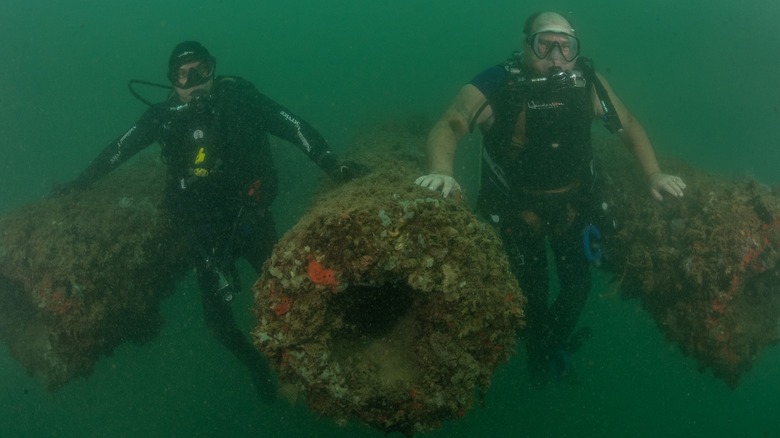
[416,12,685,388]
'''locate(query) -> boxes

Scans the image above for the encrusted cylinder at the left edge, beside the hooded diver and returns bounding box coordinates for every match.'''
[0,159,186,389]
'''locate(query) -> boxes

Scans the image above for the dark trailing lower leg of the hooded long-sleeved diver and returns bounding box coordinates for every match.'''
[196,268,276,402]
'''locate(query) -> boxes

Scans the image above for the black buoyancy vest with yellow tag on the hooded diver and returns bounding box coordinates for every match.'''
[161,77,276,216]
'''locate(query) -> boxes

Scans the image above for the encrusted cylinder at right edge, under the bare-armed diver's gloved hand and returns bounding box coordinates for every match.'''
[597,136,780,387]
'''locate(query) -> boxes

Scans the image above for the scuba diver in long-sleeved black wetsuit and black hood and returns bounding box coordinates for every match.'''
[53,41,367,401]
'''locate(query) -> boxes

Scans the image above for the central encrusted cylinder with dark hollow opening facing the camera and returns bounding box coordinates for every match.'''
[253,119,525,434]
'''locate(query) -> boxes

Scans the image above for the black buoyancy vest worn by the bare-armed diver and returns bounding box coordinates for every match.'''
[483,54,619,192]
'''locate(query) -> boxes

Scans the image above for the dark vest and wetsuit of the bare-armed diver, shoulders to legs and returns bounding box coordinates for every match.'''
[471,55,598,386]
